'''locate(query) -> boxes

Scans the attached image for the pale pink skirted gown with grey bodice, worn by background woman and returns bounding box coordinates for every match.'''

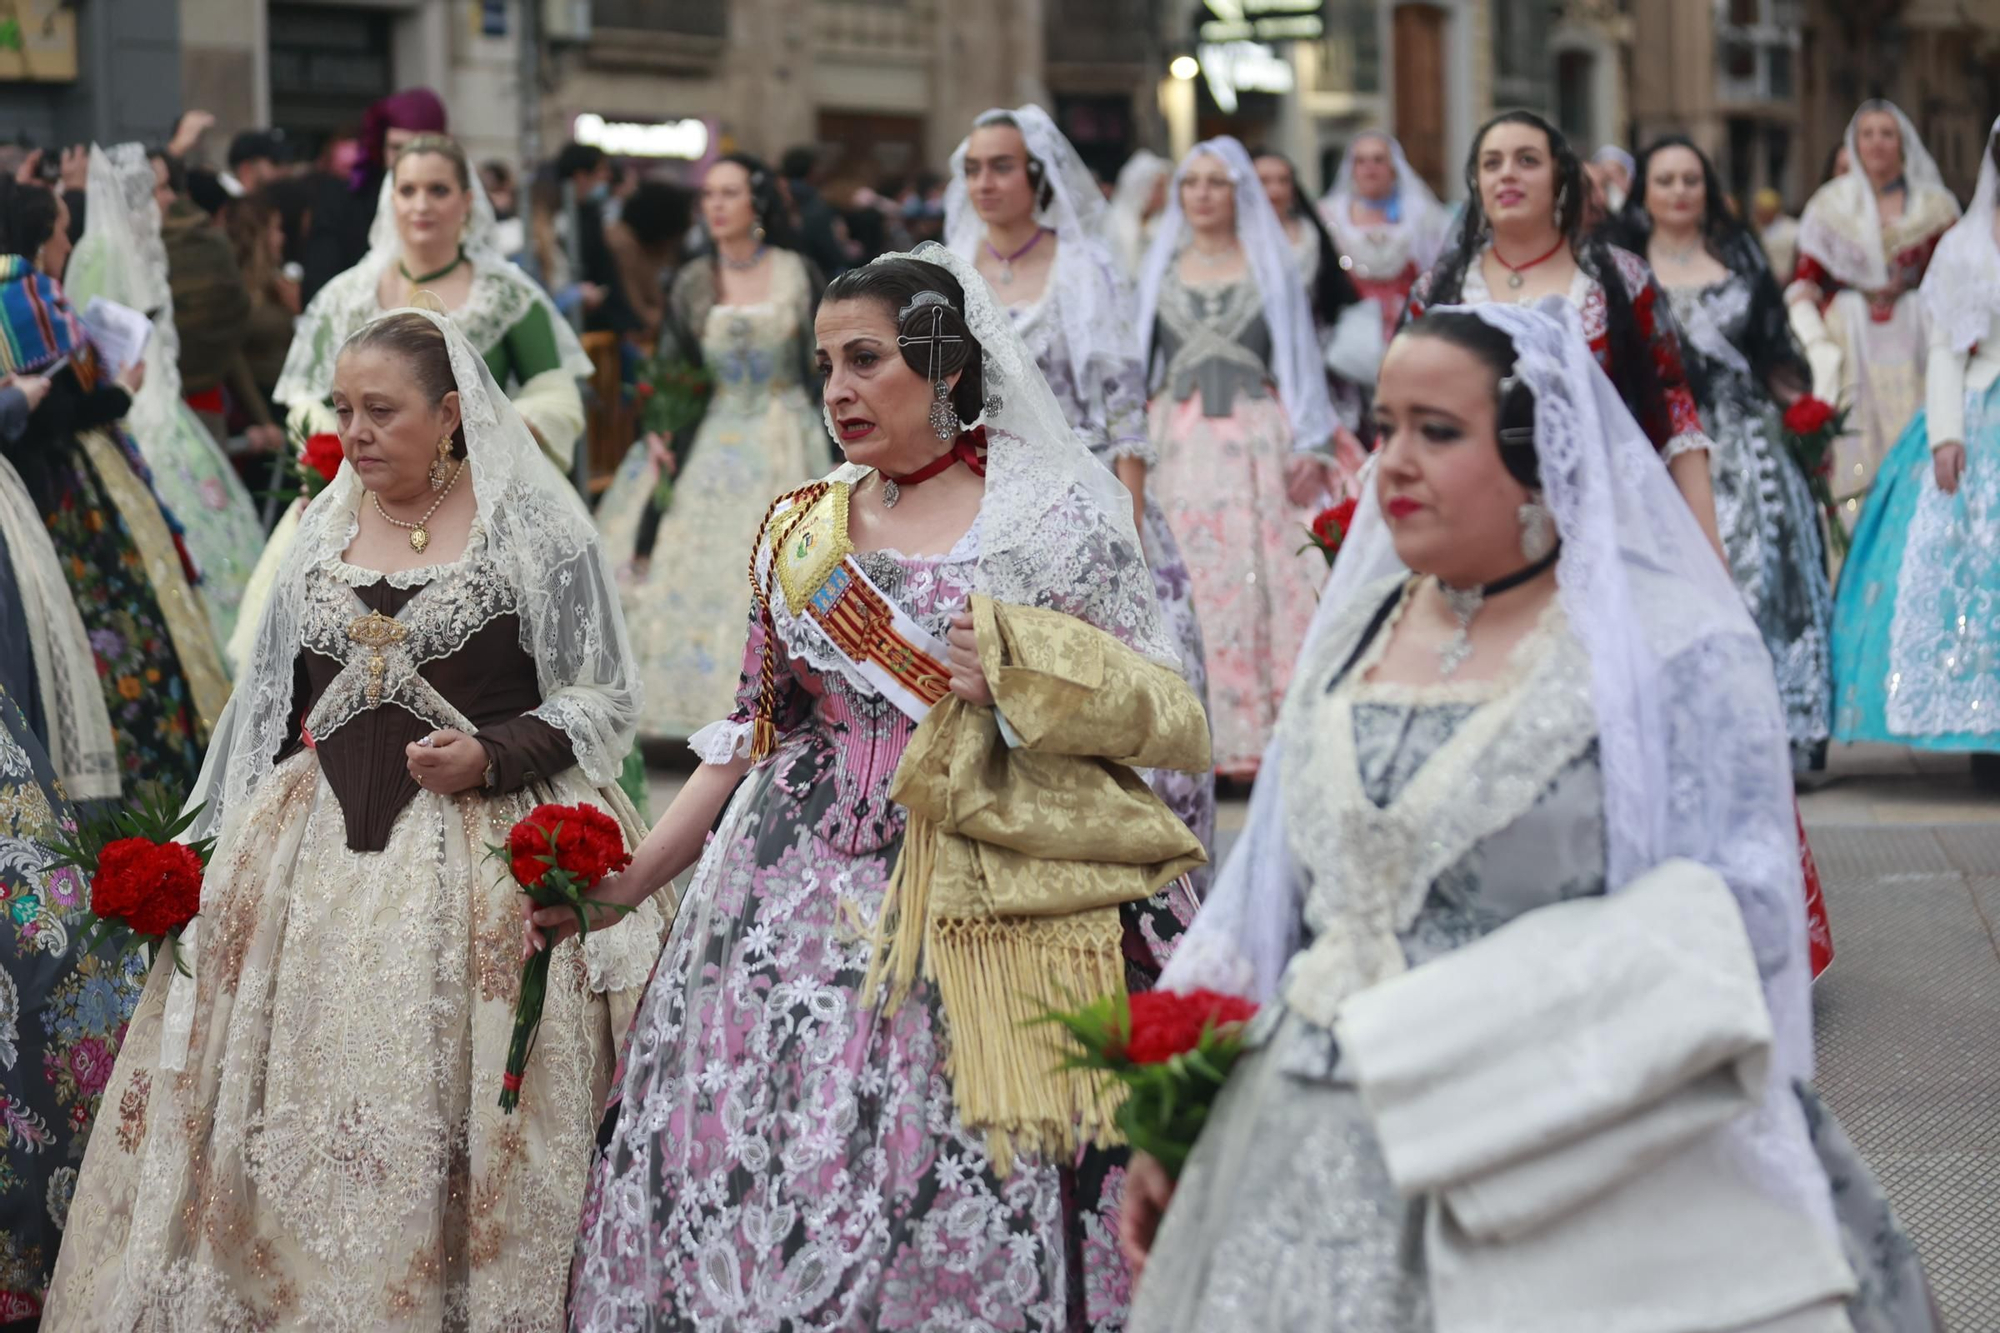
[1148,268,1326,777]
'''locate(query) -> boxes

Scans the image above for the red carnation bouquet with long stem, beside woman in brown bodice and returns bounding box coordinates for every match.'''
[488,805,632,1111]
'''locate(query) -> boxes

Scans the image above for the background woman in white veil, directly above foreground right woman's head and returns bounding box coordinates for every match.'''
[1320,130,1450,342]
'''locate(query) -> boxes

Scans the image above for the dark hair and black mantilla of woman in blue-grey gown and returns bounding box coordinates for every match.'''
[1612,134,1812,412]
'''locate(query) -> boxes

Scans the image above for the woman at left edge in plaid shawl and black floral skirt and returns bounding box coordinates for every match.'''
[0,182,230,791]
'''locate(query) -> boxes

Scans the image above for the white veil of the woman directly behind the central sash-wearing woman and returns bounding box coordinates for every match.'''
[944,104,1132,384]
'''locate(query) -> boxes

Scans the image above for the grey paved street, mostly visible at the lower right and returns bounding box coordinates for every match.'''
[652,747,2000,1333]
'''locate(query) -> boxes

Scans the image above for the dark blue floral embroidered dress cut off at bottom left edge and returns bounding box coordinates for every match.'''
[0,687,146,1329]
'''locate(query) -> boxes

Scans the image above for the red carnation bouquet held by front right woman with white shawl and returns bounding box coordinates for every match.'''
[1040,976,1256,1179]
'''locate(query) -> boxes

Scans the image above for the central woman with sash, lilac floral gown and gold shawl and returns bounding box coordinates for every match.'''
[556,246,1208,1333]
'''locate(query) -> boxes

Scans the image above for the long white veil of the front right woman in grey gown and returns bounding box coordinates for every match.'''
[1162,296,1832,1229]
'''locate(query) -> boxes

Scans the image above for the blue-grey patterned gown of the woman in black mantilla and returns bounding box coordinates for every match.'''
[1666,272,1834,769]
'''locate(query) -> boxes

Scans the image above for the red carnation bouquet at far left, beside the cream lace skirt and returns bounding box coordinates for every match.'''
[48,787,216,973]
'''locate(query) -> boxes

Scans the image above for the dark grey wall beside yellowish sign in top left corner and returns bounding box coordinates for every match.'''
[0,0,180,144]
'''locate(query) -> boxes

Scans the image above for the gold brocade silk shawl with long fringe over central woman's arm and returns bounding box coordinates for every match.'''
[862,592,1210,1171]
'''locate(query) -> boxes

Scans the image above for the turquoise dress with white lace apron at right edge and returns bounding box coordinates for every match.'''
[1834,382,2000,751]
